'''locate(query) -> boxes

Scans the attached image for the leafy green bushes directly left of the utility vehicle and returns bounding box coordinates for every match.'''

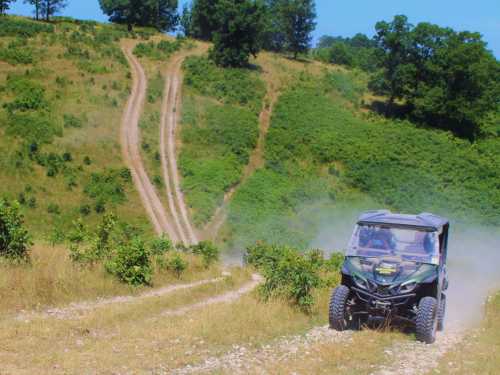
[245,243,344,311]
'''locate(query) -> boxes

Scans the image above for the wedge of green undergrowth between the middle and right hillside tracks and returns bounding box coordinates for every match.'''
[179,57,265,226]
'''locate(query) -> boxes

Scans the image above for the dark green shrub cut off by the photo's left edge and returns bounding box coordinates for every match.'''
[0,199,32,260]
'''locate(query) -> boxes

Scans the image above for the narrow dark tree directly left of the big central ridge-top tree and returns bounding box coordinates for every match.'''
[191,0,219,40]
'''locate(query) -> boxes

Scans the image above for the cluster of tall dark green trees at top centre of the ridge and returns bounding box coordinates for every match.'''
[181,0,316,62]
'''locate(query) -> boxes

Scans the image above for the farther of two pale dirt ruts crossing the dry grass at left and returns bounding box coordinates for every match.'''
[16,273,227,320]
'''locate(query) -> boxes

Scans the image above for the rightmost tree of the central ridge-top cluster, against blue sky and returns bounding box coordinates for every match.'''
[279,0,316,59]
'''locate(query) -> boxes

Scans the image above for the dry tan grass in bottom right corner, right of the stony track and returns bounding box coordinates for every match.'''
[431,294,500,375]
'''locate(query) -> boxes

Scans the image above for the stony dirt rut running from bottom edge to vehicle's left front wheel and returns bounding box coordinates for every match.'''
[172,326,352,375]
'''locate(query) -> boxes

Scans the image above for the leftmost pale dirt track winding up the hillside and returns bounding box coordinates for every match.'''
[121,45,179,241]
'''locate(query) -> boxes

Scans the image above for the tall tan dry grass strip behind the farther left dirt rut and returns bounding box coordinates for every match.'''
[0,244,225,316]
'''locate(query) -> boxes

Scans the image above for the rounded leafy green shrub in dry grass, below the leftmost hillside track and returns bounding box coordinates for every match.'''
[105,237,152,285]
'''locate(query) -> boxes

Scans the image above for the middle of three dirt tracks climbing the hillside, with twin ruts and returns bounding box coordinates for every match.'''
[160,54,198,245]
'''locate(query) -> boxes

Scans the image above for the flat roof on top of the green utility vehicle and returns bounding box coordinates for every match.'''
[358,210,449,230]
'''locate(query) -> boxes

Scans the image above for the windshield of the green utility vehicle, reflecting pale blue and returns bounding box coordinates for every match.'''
[347,225,439,264]
